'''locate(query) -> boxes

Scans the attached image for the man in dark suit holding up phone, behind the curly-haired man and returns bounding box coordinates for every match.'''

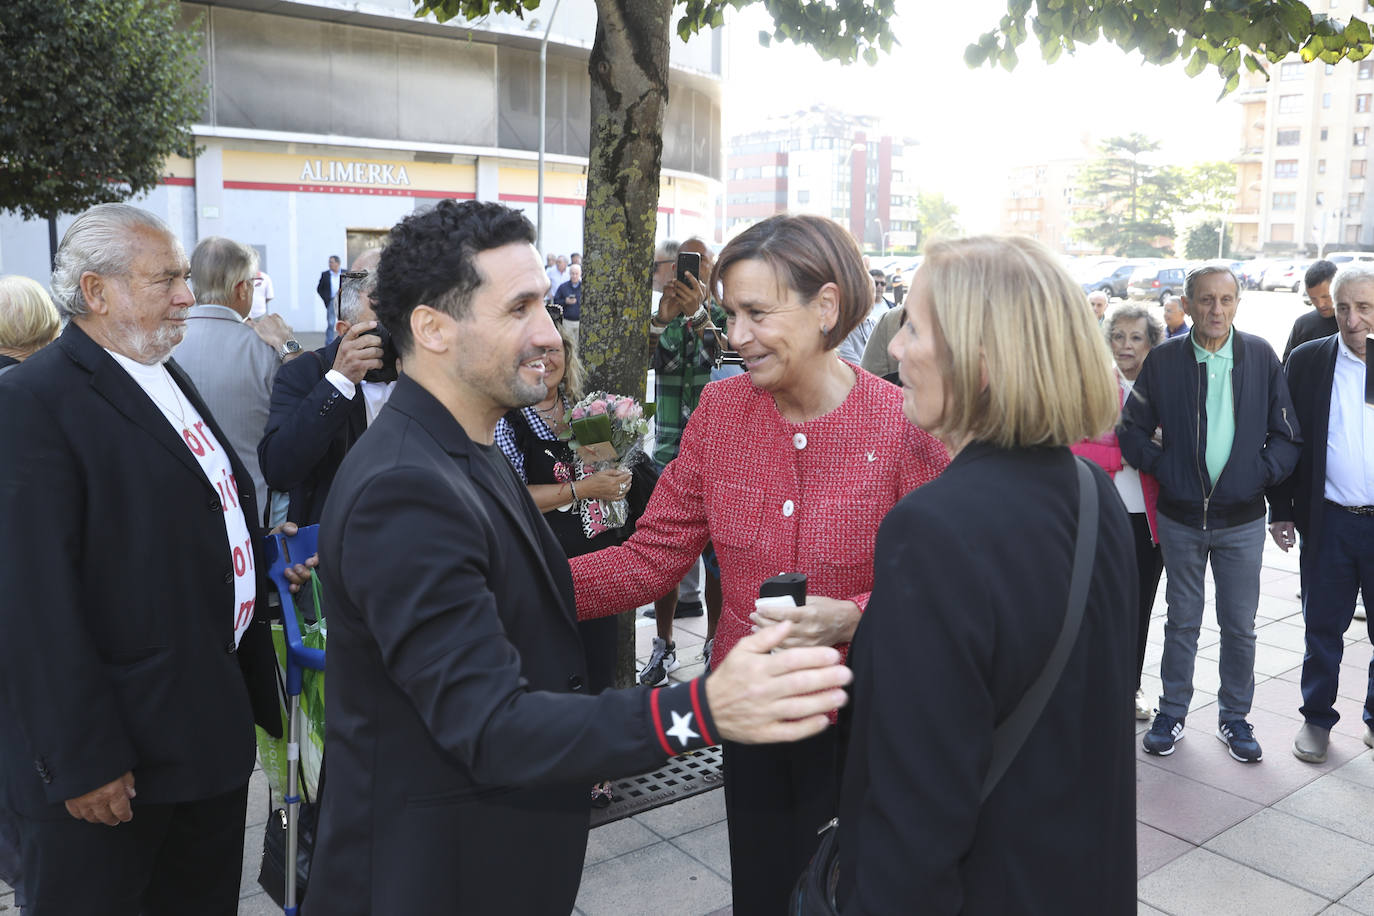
[258,249,396,525]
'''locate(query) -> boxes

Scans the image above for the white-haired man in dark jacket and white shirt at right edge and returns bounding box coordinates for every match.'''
[1268,265,1374,764]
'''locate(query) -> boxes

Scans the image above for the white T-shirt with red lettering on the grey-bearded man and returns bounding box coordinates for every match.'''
[106,350,257,645]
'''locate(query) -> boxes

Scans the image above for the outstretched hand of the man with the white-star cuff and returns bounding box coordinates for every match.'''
[705,623,853,744]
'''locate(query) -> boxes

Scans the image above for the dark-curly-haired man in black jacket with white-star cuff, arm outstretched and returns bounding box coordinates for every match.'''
[305,201,849,916]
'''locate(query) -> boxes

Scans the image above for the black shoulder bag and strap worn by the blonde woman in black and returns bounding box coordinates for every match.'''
[787,457,1098,916]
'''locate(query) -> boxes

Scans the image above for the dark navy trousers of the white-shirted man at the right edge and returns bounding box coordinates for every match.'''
[1301,505,1374,729]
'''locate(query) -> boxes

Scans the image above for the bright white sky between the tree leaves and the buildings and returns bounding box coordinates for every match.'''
[724,0,1241,231]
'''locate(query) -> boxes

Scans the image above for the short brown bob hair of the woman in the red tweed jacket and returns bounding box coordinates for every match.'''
[710,213,872,350]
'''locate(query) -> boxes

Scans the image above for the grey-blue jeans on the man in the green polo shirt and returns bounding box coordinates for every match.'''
[1158,514,1264,722]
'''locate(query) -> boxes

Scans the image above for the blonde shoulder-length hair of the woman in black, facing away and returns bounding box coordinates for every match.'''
[921,236,1118,448]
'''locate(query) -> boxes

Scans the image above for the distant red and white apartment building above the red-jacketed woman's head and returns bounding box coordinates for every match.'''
[725,106,916,250]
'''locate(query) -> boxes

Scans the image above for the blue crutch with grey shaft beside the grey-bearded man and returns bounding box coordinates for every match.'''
[259,525,324,916]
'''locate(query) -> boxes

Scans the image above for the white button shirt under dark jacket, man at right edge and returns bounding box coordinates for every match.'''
[1323,335,1374,505]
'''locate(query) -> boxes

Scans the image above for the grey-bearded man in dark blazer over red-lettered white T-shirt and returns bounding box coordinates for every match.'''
[0,203,280,916]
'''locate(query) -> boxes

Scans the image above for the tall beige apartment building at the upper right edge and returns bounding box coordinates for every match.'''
[1228,47,1374,255]
